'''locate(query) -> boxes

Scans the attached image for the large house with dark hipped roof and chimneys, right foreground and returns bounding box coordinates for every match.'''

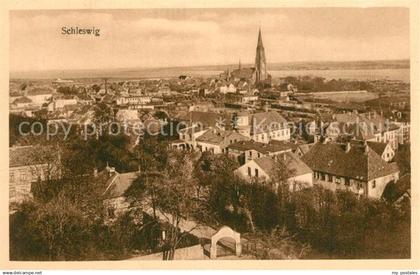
[302,143,399,199]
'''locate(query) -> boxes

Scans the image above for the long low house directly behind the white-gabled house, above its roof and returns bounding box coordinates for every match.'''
[228,140,294,165]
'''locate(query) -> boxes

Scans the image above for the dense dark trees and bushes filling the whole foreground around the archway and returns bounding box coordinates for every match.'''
[10,117,410,260]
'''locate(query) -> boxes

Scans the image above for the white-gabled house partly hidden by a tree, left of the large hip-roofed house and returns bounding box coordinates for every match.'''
[235,152,313,191]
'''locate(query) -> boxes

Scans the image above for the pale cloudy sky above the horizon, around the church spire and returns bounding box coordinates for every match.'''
[10,8,410,71]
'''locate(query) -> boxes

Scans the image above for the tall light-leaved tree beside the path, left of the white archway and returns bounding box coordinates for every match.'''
[126,151,201,260]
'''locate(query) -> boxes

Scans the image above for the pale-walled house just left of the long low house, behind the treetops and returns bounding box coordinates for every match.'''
[196,128,249,154]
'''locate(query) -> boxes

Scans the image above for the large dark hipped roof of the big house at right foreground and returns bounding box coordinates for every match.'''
[302,143,399,181]
